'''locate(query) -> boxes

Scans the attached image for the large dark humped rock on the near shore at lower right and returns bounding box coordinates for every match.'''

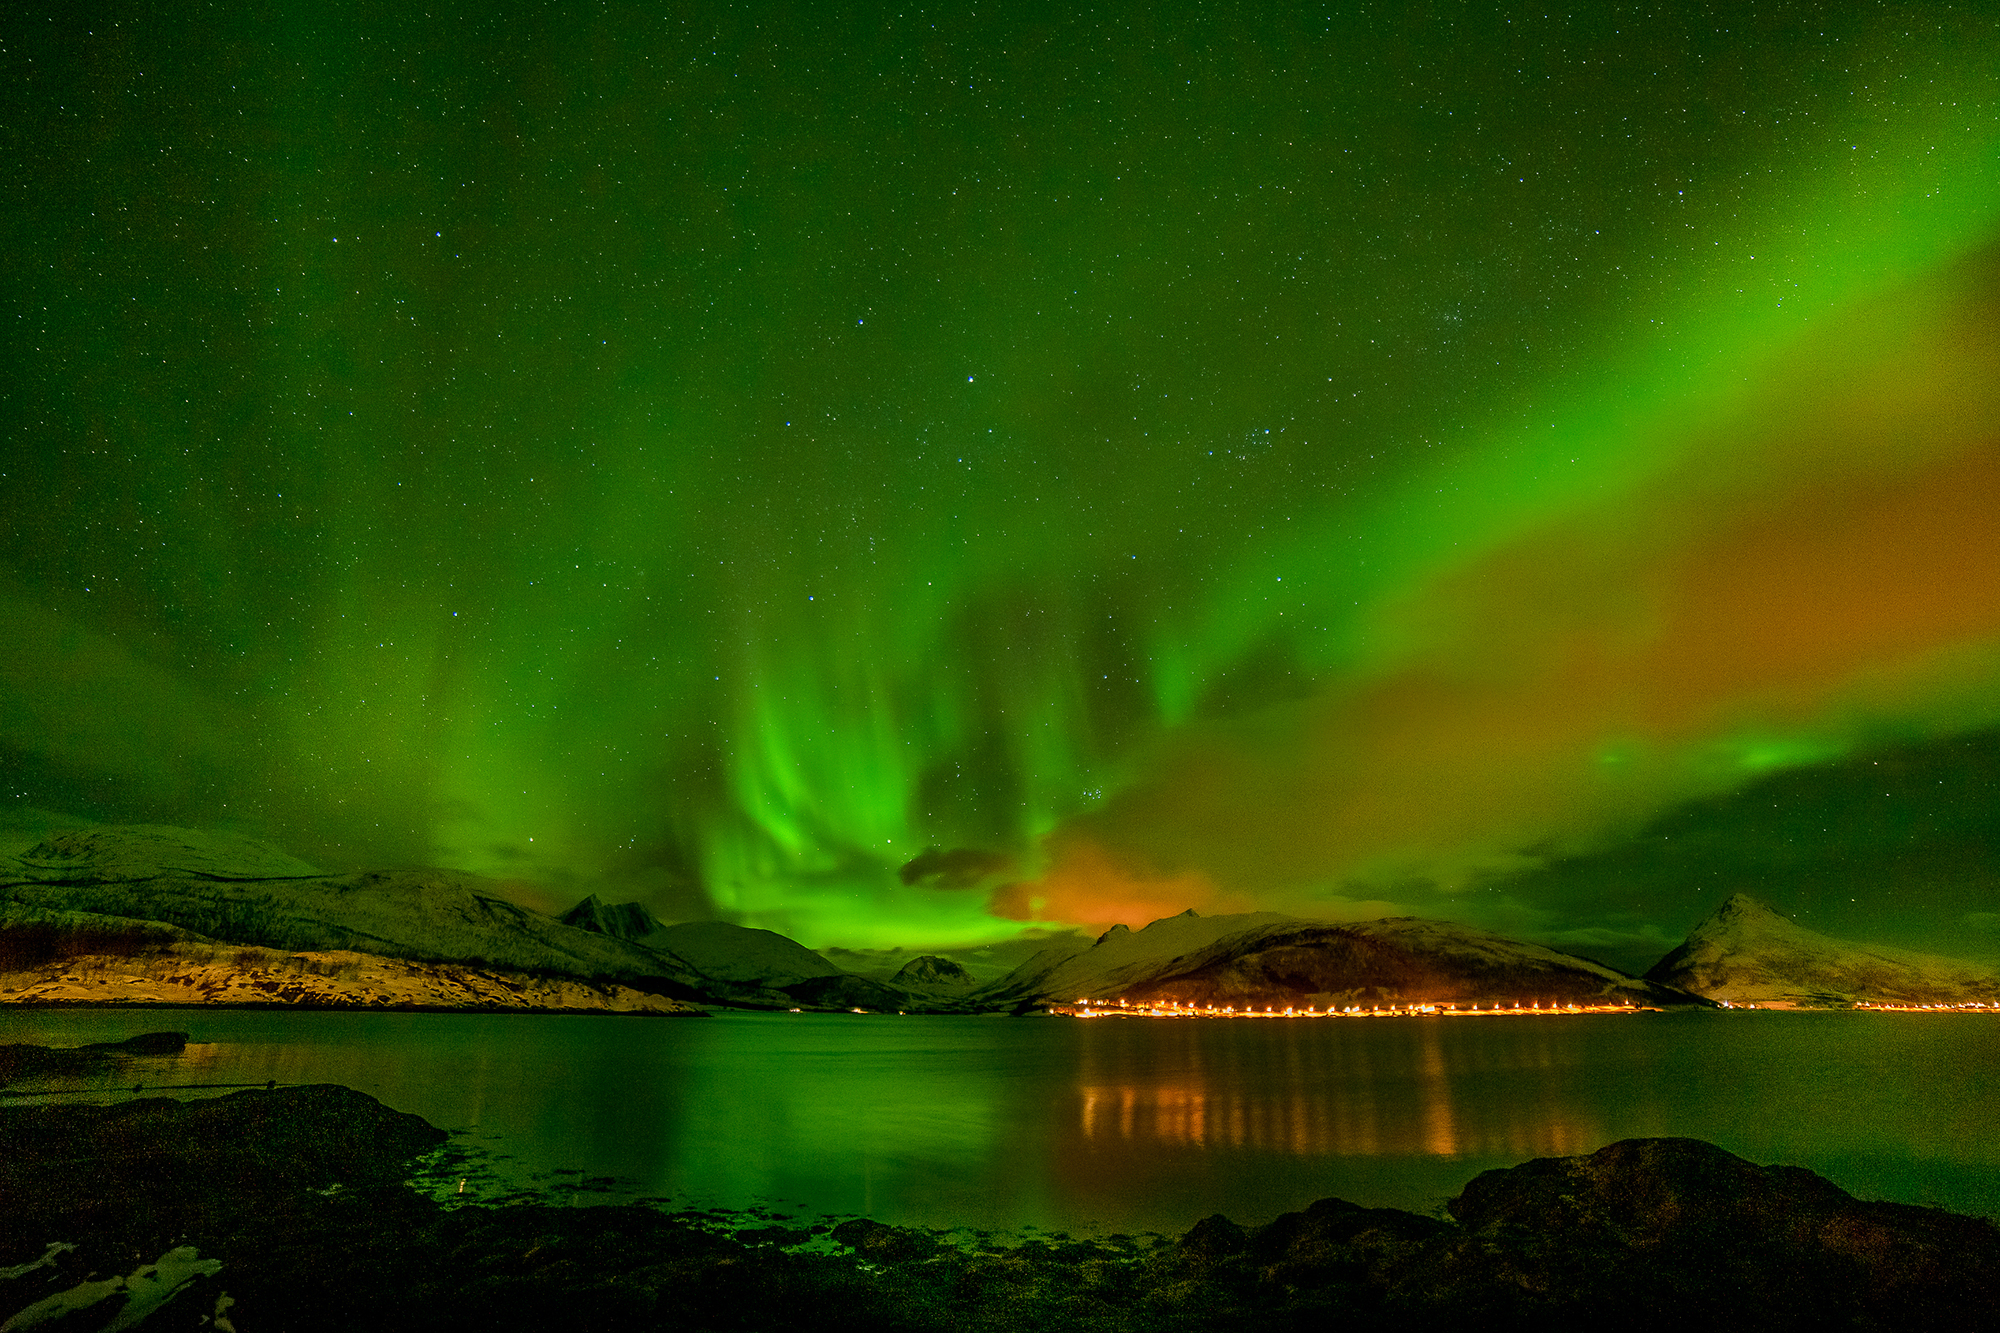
[1402,1139,2000,1329]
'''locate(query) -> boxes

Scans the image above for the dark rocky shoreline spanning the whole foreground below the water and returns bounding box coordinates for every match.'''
[0,1040,2000,1333]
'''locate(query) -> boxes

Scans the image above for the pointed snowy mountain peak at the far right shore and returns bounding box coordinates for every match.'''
[1646,893,2000,1009]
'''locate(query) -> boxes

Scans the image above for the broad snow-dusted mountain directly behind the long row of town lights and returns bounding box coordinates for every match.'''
[972,913,1700,1009]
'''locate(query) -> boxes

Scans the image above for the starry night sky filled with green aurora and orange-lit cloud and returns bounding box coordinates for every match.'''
[0,2,2000,967]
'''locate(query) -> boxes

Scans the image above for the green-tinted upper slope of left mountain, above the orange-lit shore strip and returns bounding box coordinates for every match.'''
[0,825,700,993]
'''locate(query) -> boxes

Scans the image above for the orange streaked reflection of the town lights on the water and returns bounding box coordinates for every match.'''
[1076,1019,1606,1157]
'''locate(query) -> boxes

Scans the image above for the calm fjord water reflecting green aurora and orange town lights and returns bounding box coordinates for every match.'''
[0,1011,2000,1231]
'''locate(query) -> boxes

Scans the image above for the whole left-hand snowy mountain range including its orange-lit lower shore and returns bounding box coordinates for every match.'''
[0,825,970,1013]
